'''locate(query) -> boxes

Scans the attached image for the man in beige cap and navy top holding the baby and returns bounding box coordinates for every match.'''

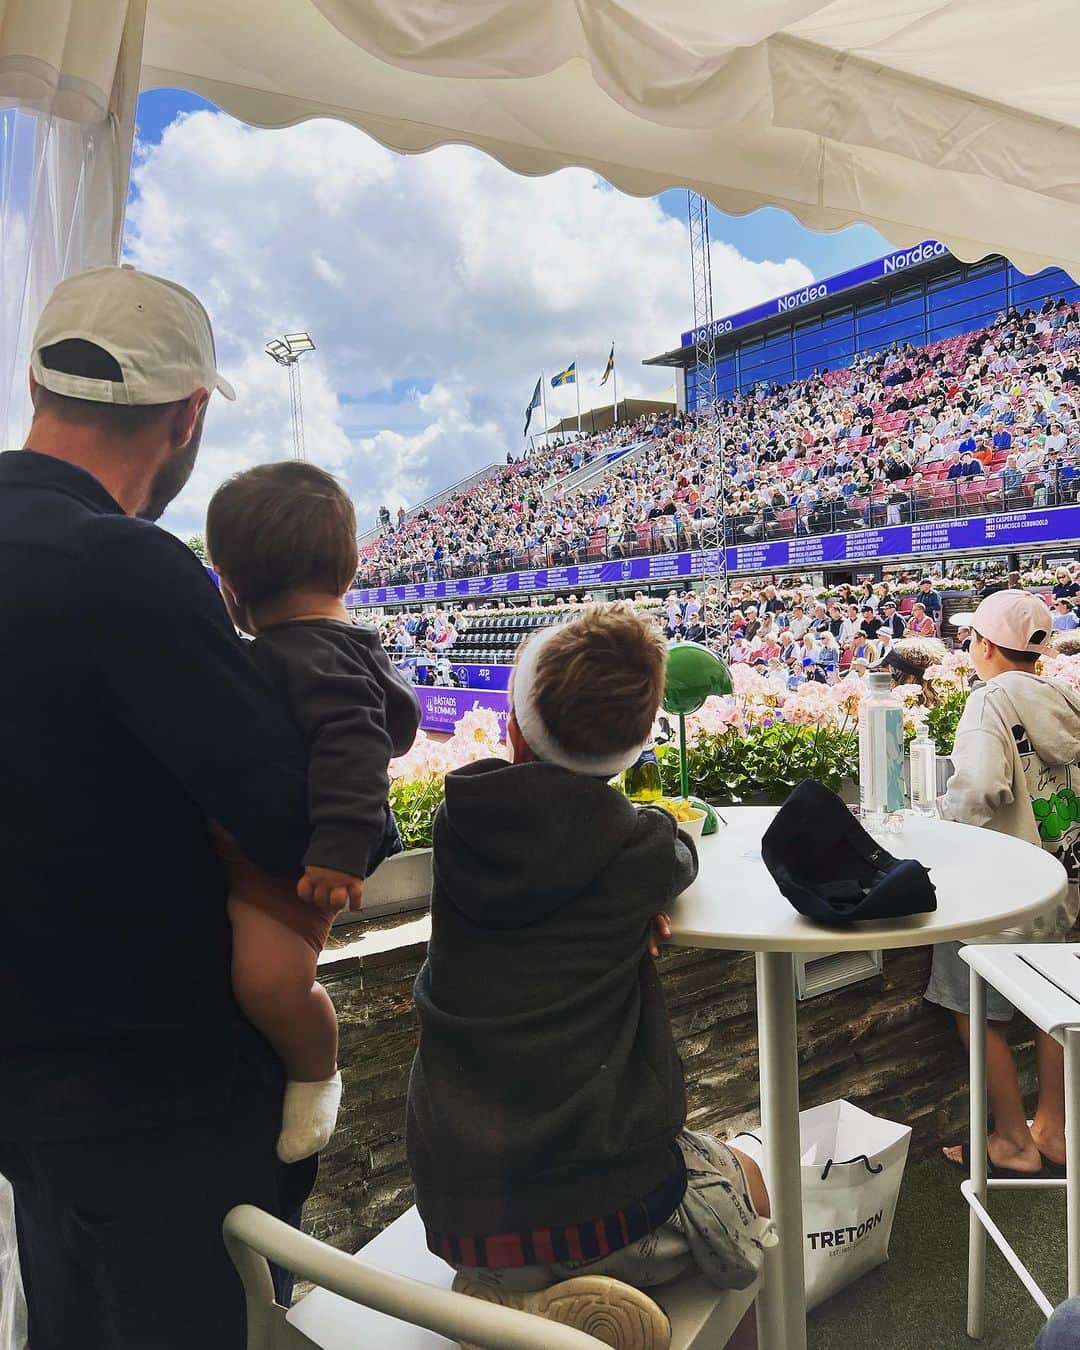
[0,267,315,1350]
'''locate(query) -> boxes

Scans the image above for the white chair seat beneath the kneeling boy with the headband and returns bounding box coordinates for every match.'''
[286,1208,757,1350]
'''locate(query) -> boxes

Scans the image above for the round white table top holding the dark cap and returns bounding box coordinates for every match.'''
[671,806,1067,952]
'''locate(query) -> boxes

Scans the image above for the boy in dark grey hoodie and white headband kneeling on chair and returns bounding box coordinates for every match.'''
[408,605,775,1350]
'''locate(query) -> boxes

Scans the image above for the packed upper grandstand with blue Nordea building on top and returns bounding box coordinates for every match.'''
[352,243,1080,615]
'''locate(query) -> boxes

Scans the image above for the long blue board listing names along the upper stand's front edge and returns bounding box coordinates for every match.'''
[346,506,1080,609]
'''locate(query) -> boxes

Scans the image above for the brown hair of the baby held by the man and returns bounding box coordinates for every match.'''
[207,460,356,608]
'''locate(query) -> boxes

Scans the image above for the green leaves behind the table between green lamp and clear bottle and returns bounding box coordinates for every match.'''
[656,722,859,806]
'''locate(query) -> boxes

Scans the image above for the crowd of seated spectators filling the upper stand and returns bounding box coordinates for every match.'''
[358,300,1080,585]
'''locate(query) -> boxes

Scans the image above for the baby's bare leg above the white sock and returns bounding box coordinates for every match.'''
[228,900,338,1083]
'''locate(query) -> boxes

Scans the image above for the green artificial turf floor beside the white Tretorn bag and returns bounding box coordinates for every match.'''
[799,1160,1067,1350]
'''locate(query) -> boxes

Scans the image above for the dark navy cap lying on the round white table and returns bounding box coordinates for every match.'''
[761,779,937,923]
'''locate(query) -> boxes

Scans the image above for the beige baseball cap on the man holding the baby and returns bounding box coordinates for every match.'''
[30,266,236,406]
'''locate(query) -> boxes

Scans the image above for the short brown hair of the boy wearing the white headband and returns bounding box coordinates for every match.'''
[521,601,667,757]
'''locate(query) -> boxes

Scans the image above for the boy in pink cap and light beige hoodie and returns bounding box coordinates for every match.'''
[926,590,1080,1177]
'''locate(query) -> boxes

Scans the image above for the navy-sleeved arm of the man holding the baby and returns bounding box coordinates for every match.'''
[81,516,308,876]
